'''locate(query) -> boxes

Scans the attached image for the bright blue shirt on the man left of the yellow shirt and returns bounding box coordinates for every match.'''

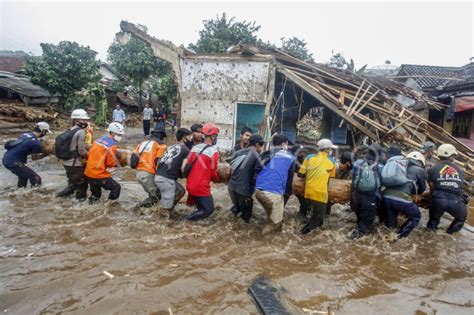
[255,149,295,195]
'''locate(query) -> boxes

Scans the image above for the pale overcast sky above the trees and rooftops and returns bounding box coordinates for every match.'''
[0,0,474,67]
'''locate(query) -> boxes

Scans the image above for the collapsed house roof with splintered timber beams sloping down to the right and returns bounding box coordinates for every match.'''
[120,21,474,176]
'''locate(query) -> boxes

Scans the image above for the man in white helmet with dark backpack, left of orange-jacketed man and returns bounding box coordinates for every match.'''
[55,109,90,201]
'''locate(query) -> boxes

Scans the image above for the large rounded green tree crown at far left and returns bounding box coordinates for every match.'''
[25,41,101,99]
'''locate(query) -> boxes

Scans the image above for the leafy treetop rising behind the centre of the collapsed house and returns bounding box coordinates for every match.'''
[188,13,260,53]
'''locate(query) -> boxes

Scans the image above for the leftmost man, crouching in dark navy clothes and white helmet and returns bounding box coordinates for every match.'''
[3,121,51,188]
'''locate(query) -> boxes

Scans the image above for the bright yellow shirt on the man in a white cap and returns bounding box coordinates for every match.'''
[298,152,336,203]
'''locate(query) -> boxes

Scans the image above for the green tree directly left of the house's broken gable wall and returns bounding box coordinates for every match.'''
[107,25,158,106]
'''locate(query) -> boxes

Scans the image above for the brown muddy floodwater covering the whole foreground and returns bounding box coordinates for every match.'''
[0,135,474,315]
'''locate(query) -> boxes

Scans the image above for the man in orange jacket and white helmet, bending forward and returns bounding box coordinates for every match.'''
[84,122,125,204]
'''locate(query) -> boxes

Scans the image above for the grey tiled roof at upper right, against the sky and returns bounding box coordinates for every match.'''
[397,65,465,88]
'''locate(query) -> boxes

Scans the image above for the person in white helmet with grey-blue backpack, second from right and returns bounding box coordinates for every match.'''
[382,146,426,238]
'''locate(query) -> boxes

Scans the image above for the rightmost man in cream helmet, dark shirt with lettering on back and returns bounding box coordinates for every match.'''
[427,143,469,234]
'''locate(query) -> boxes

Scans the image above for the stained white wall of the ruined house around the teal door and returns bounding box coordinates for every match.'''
[181,57,270,151]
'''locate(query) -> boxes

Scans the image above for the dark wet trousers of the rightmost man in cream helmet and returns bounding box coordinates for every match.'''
[427,196,467,234]
